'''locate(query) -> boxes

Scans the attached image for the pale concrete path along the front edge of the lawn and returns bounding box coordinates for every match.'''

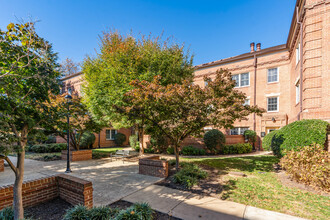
[122,185,302,220]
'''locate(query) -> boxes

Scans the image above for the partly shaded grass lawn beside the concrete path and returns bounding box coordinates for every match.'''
[183,156,330,219]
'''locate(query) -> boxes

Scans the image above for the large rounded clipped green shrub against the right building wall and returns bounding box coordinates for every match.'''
[271,119,329,157]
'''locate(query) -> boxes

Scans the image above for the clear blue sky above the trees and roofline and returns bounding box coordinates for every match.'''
[0,0,296,65]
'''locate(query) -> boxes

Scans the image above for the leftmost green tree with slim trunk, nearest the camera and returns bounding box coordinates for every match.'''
[0,23,60,219]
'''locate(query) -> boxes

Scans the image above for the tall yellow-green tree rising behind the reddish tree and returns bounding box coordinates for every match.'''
[83,32,194,154]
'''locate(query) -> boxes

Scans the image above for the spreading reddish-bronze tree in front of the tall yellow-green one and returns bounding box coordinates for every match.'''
[116,70,263,169]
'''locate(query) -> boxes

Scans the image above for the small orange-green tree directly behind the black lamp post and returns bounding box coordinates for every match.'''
[47,93,105,150]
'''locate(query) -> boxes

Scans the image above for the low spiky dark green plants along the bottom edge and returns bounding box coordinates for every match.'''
[64,203,153,220]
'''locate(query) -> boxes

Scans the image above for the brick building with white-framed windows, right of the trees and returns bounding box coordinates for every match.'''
[194,0,330,146]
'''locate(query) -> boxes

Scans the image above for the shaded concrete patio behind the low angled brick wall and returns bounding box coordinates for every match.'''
[0,157,161,206]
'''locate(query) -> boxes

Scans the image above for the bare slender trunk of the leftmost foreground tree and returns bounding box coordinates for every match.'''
[14,137,27,220]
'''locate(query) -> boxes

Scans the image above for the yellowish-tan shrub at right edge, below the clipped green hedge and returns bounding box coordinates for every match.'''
[280,144,330,192]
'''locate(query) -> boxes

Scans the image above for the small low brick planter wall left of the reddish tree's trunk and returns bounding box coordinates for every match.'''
[139,156,168,178]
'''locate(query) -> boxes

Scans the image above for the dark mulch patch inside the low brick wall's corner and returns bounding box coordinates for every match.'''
[24,198,73,220]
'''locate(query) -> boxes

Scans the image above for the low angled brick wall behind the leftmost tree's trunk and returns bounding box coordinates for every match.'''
[0,174,93,210]
